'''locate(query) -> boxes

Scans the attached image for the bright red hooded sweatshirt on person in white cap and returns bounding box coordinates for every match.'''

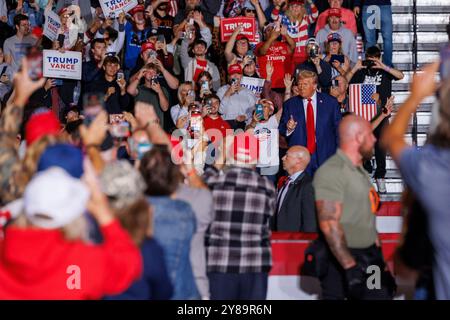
[0,221,142,300]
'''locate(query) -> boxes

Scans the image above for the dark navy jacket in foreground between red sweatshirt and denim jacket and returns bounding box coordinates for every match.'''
[105,239,173,300]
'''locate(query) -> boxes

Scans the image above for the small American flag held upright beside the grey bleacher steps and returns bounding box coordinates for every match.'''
[349,83,377,121]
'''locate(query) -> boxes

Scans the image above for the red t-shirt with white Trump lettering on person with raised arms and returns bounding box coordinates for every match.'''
[255,41,291,88]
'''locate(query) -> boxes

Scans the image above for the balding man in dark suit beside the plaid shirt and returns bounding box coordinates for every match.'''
[272,146,318,232]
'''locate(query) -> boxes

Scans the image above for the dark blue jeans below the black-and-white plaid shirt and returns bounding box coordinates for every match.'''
[208,272,269,300]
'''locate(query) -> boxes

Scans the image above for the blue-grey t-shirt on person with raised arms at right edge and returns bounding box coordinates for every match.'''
[398,145,450,300]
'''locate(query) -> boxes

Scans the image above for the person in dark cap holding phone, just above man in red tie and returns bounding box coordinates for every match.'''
[324,33,350,78]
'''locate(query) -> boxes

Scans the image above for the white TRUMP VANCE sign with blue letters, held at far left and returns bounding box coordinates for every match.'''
[44,50,82,80]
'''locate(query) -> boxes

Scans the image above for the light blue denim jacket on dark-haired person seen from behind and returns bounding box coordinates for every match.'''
[148,196,200,300]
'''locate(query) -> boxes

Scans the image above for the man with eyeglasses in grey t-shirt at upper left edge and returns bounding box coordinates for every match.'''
[3,14,36,73]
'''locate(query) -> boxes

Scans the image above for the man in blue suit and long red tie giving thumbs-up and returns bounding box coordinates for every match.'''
[279,70,342,177]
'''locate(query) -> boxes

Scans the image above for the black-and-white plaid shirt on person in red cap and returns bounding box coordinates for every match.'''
[204,167,276,273]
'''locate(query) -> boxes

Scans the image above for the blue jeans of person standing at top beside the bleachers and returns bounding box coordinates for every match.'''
[362,5,393,67]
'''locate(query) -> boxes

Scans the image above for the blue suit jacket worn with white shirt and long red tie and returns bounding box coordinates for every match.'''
[279,92,342,176]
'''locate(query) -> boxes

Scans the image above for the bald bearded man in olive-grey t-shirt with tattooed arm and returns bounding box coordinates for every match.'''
[313,115,395,300]
